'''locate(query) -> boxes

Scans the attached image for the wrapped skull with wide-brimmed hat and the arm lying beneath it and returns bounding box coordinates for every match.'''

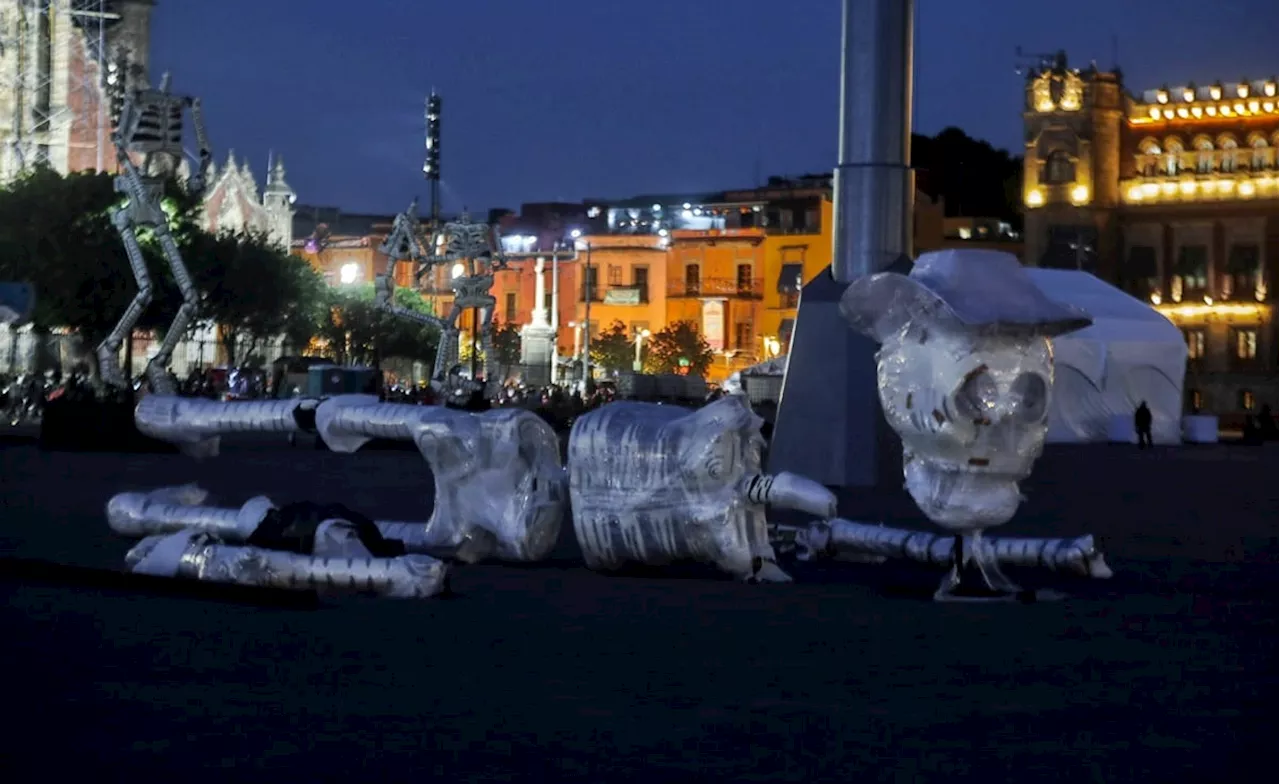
[801,251,1110,601]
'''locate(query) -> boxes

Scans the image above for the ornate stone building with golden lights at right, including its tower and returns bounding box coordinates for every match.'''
[1023,55,1280,421]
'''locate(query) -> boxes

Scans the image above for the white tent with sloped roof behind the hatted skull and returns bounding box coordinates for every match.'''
[1027,269,1187,443]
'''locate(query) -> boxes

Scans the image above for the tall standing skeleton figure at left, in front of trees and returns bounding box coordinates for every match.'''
[97,74,212,395]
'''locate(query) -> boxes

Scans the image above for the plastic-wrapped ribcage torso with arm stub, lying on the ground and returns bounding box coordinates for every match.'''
[568,396,836,582]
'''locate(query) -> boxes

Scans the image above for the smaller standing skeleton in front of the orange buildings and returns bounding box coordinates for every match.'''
[374,201,507,393]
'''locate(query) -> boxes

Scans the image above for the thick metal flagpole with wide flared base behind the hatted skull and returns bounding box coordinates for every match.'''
[769,0,915,497]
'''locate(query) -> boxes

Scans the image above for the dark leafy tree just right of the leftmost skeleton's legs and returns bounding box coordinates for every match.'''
[187,232,326,365]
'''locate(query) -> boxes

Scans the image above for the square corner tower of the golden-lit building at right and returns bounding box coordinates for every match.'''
[1023,53,1125,275]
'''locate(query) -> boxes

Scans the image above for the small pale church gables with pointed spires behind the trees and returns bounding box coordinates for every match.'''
[205,152,297,249]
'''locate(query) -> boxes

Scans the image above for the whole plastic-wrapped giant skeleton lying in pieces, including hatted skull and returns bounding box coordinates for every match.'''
[108,254,1110,600]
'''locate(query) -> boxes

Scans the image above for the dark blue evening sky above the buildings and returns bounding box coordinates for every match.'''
[151,0,1280,213]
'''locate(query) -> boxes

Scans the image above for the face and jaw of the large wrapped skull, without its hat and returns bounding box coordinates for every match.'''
[877,325,1053,529]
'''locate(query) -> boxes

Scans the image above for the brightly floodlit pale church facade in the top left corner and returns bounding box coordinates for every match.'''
[0,0,120,182]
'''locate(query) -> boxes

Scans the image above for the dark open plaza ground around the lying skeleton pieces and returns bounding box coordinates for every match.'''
[0,432,1280,783]
